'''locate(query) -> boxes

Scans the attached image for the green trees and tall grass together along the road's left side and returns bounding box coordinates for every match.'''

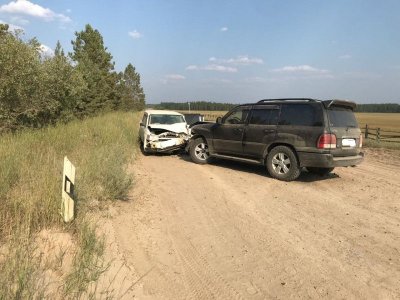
[0,24,145,299]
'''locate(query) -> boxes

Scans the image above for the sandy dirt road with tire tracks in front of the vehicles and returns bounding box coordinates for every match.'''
[102,150,400,299]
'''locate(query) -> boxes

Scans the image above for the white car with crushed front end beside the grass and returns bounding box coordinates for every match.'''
[139,110,189,153]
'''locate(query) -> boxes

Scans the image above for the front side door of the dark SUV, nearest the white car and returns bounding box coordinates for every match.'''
[212,106,250,155]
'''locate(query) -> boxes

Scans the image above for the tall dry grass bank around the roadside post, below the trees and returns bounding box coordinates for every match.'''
[0,112,140,299]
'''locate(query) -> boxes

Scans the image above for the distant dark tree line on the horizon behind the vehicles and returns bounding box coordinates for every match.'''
[148,101,400,113]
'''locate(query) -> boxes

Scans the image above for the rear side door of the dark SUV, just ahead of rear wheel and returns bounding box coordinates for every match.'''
[243,105,279,158]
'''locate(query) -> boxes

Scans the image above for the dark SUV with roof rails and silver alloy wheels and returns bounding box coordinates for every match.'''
[189,98,364,181]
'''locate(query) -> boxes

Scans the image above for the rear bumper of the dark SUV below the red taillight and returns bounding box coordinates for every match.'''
[298,152,364,168]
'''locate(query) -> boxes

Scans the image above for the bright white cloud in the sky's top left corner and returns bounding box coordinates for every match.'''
[0,0,71,23]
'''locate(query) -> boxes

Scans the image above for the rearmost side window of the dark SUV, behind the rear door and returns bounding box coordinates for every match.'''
[278,103,323,127]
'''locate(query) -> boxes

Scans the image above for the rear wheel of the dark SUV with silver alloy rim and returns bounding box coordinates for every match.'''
[266,146,301,181]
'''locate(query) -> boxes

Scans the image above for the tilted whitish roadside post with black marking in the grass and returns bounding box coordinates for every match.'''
[61,156,75,222]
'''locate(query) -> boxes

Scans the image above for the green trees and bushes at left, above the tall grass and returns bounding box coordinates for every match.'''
[0,24,145,132]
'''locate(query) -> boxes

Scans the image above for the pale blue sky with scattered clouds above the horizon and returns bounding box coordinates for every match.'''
[0,0,400,103]
